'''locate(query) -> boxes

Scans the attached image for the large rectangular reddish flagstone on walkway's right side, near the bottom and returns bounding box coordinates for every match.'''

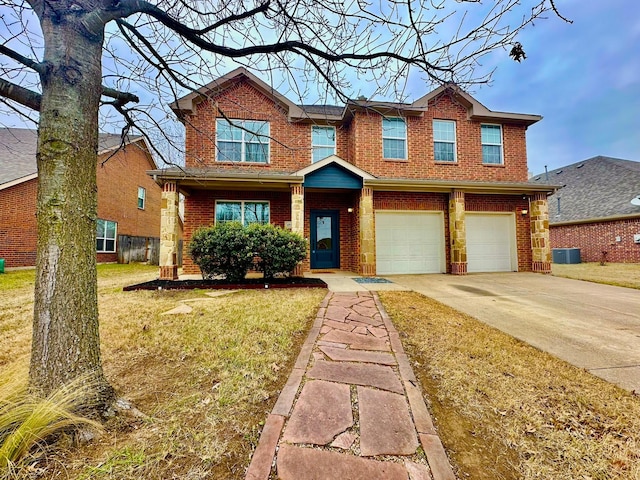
[358,387,418,456]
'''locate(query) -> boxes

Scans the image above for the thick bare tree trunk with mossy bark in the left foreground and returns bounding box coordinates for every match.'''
[30,7,114,405]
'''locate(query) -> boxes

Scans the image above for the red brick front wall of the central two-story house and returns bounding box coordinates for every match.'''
[171,72,552,274]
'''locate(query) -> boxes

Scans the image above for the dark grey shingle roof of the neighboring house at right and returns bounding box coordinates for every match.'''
[530,156,640,224]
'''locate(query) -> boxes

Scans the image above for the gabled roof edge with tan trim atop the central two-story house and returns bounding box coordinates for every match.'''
[169,67,542,126]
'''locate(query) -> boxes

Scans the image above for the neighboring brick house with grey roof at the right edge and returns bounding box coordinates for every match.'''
[531,156,640,263]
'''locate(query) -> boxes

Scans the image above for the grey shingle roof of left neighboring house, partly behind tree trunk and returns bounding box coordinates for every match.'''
[0,128,157,189]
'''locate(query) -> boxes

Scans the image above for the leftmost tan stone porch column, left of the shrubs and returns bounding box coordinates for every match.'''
[160,182,179,280]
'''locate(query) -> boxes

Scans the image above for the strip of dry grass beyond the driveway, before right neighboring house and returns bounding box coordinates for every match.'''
[551,263,640,289]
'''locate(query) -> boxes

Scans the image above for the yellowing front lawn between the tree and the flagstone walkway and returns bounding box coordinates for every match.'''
[0,265,326,480]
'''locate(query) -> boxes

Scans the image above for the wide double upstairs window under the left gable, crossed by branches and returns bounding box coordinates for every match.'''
[216,119,269,163]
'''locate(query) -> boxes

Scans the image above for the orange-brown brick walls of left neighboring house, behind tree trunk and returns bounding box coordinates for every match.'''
[0,144,161,268]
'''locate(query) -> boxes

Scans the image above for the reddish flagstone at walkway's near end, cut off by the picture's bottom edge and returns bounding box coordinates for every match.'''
[277,445,407,480]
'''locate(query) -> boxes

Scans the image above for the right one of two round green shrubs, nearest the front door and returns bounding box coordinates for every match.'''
[247,223,307,278]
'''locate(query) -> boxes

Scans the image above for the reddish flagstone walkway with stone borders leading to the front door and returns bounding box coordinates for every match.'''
[246,291,455,480]
